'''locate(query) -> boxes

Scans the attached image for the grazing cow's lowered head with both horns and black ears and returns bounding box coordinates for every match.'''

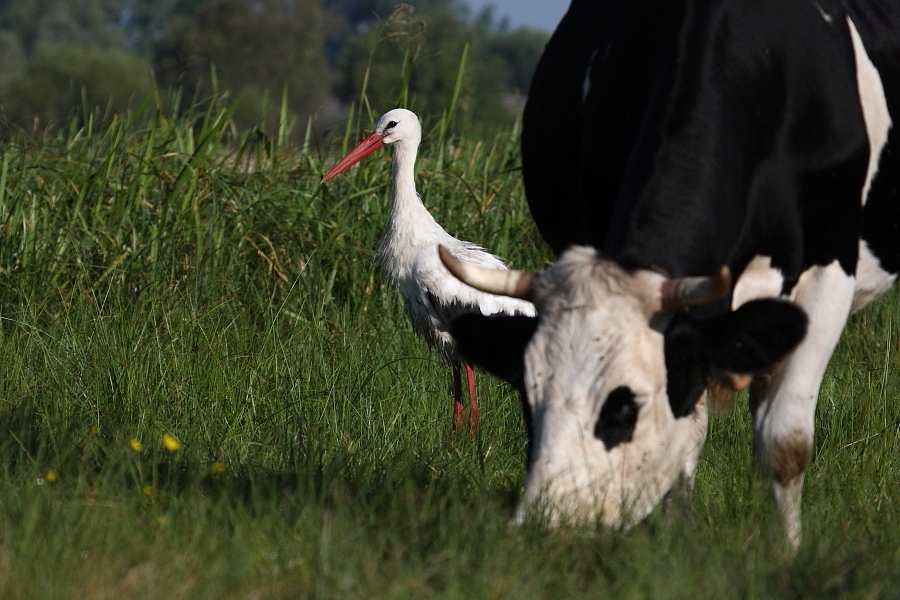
[441,247,806,527]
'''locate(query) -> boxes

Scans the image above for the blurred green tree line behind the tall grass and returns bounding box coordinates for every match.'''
[0,0,552,135]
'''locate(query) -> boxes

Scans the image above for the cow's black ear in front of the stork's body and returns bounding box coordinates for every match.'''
[450,313,538,391]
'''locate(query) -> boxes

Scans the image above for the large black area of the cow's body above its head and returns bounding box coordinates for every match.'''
[522,0,884,289]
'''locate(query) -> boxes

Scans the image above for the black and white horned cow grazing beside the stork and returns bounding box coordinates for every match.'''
[445,0,900,546]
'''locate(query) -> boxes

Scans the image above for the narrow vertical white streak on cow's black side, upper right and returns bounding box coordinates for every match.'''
[847,18,891,206]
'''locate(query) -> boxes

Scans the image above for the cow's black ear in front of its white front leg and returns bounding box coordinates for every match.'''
[697,298,808,374]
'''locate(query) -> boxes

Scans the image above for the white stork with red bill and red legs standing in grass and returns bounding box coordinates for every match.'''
[322,108,535,433]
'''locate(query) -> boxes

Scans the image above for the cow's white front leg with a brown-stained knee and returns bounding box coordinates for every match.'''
[751,261,854,549]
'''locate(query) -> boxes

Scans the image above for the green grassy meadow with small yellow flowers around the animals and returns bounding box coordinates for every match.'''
[0,96,900,600]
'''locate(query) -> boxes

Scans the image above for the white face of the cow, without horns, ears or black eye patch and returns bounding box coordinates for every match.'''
[516,248,707,527]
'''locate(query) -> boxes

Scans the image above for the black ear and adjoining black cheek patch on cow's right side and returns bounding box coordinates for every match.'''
[665,298,808,417]
